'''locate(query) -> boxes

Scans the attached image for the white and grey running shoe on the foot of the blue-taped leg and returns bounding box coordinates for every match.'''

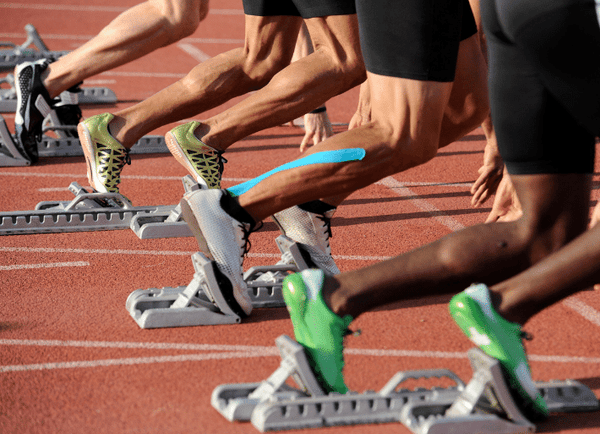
[180,189,253,316]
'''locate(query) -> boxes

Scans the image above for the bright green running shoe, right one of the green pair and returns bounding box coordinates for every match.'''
[450,284,548,422]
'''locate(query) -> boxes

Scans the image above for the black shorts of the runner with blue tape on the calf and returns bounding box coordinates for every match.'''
[356,0,477,82]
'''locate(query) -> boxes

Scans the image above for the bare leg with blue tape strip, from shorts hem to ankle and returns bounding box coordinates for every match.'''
[239,73,452,221]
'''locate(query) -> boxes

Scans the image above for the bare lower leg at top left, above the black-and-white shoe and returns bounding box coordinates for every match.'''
[43,0,208,97]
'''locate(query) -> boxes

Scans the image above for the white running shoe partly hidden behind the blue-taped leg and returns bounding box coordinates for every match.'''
[272,201,340,274]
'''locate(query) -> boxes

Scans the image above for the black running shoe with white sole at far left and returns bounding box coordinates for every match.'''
[15,59,52,163]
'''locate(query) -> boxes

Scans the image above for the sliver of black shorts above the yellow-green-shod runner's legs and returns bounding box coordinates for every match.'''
[244,0,356,18]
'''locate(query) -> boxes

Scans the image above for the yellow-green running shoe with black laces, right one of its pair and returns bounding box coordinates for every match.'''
[165,121,226,188]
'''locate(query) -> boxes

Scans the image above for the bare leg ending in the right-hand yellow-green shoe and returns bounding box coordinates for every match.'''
[196,15,364,150]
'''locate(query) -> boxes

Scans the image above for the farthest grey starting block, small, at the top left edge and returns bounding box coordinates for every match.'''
[0,24,68,71]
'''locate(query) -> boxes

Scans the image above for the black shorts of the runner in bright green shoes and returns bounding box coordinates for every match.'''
[481,0,600,175]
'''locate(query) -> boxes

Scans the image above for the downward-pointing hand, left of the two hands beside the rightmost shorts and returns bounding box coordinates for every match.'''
[471,139,504,208]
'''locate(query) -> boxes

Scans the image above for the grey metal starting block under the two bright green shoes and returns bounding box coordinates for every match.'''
[211,335,599,434]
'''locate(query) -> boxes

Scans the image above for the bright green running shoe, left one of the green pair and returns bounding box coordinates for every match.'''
[283,270,352,393]
